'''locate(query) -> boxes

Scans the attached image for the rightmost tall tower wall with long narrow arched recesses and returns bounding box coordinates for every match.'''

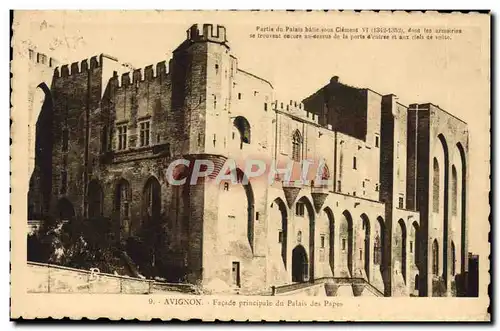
[410,104,468,295]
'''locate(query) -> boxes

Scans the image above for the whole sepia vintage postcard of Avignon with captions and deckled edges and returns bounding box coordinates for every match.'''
[11,11,491,321]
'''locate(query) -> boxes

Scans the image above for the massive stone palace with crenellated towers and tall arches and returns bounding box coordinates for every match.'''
[27,24,468,296]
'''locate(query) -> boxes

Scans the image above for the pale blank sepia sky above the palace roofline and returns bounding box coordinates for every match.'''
[14,11,490,252]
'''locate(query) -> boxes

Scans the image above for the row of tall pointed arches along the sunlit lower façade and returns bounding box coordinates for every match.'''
[269,196,420,295]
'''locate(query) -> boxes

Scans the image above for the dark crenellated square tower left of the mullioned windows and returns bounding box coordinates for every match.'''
[50,54,127,219]
